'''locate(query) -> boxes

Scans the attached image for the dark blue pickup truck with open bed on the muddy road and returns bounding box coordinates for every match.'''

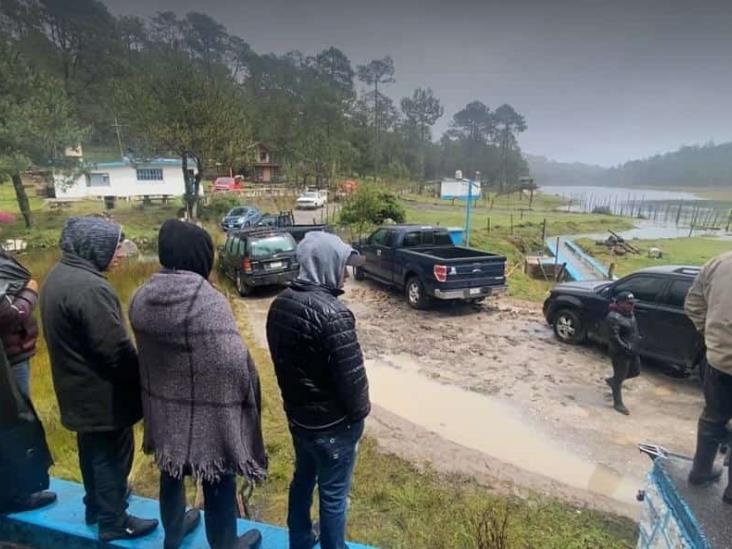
[354,225,506,309]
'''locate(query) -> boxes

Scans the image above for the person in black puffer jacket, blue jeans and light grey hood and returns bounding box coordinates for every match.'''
[267,232,371,549]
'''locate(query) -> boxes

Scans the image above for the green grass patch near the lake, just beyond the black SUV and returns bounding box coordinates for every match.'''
[577,237,732,276]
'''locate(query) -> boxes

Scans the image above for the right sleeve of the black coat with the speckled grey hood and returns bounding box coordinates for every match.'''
[78,285,138,371]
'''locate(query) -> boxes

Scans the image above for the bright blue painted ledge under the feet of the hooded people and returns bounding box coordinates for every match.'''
[0,479,374,549]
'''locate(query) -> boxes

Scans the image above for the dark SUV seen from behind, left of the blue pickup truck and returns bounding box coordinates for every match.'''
[219,227,300,296]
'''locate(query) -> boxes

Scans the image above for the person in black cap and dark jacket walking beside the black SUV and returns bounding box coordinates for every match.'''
[605,292,641,416]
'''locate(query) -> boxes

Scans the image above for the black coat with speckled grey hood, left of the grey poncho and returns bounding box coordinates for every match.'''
[40,217,142,432]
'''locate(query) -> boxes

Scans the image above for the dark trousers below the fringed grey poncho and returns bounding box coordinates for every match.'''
[160,472,237,549]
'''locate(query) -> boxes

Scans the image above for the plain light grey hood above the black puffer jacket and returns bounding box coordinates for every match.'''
[297,231,354,290]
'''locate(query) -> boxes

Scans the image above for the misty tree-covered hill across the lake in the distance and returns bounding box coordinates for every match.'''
[526,143,732,188]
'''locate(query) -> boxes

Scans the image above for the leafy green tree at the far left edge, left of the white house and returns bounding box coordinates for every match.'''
[0,44,86,227]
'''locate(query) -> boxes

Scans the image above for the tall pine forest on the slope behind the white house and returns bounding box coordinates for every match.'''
[0,0,527,207]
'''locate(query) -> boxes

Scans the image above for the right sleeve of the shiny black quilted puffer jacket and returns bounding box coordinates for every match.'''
[323,310,371,421]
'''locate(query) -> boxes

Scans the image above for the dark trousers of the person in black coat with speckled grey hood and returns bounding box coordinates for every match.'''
[76,427,135,531]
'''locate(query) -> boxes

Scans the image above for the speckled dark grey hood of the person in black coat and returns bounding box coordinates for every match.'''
[59,217,122,271]
